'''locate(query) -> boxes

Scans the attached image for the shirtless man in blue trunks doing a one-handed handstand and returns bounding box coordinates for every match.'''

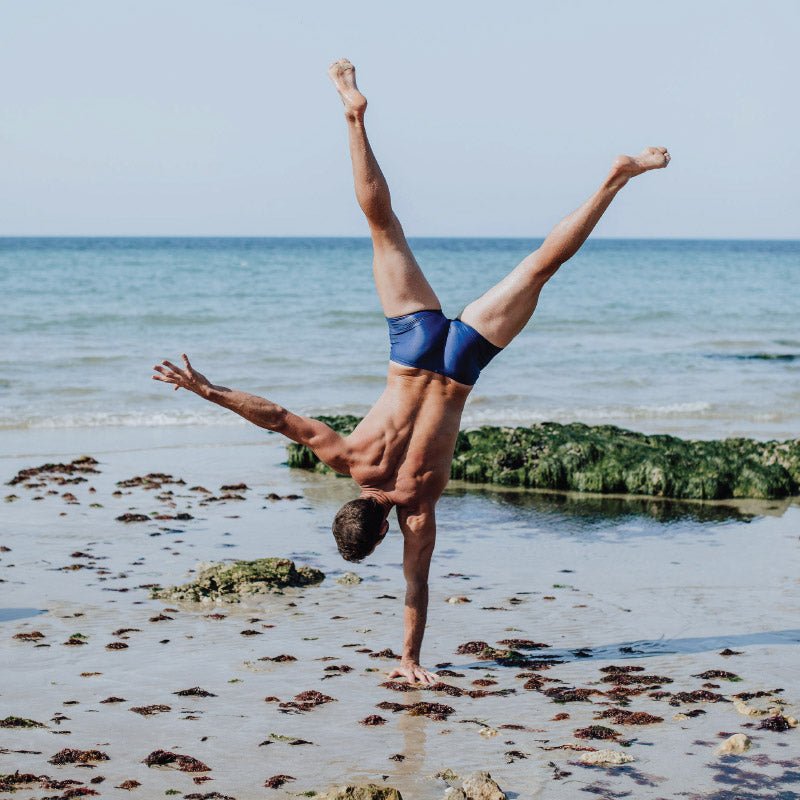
[153,60,670,683]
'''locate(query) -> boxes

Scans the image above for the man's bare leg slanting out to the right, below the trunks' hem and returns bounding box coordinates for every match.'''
[461,147,670,347]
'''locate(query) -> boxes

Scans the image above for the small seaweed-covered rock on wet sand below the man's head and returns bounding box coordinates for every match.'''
[151,558,325,603]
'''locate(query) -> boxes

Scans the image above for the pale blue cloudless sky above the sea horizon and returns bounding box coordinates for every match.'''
[0,0,800,238]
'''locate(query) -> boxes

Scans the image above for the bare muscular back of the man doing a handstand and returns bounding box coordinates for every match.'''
[347,363,472,507]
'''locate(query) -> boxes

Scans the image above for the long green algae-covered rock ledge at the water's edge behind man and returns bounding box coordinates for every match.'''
[289,415,800,500]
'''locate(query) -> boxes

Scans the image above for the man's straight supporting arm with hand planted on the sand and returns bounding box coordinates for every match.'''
[389,508,438,684]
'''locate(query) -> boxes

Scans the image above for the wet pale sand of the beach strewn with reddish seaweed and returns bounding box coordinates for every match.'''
[0,428,800,800]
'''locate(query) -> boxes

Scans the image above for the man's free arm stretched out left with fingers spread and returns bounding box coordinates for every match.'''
[153,353,350,474]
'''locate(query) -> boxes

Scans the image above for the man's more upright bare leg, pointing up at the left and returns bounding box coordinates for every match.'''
[328,59,441,317]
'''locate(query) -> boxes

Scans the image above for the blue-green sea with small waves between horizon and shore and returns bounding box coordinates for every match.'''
[0,238,800,438]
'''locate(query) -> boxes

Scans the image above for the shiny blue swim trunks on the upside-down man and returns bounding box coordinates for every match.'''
[386,311,503,386]
